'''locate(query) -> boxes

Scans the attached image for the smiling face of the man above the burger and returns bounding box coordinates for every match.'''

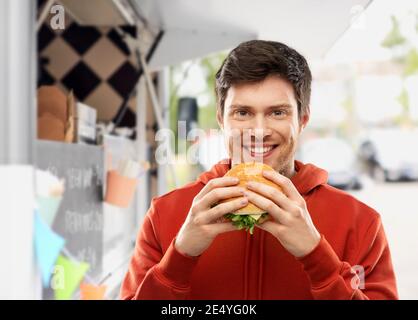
[217,76,309,175]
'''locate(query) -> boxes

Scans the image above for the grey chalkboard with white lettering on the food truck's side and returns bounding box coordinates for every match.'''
[36,140,104,279]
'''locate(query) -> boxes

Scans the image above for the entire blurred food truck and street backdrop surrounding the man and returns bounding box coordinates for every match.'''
[0,0,418,299]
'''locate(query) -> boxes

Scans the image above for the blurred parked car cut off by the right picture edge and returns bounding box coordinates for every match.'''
[360,129,418,182]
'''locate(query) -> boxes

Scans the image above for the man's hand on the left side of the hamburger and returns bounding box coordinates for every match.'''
[175,177,248,256]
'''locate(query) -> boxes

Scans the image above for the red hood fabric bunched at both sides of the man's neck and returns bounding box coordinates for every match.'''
[198,159,328,195]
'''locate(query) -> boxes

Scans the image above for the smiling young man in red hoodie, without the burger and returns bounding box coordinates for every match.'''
[121,41,397,299]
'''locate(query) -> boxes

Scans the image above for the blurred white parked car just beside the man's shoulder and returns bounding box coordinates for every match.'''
[297,137,362,190]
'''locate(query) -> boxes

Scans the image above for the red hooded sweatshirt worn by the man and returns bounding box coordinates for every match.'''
[121,160,398,299]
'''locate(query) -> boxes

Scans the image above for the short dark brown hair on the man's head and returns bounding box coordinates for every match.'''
[215,40,312,120]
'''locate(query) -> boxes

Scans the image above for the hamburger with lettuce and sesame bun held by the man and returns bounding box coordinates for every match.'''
[220,162,282,234]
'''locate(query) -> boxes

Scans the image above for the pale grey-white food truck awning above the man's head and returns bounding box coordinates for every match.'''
[135,0,371,68]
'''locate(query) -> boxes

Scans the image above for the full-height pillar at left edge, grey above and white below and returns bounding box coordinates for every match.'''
[0,0,40,299]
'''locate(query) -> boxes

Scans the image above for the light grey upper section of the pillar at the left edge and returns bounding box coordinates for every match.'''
[0,0,36,164]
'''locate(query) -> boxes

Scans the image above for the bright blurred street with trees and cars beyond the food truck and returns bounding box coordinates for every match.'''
[168,0,418,299]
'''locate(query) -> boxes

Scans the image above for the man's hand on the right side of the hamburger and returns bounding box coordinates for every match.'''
[245,171,321,257]
